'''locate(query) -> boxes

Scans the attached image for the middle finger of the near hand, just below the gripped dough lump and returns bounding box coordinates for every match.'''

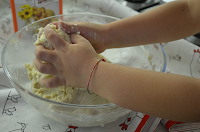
[35,45,57,63]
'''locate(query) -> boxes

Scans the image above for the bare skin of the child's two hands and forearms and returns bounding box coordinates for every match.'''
[34,0,200,122]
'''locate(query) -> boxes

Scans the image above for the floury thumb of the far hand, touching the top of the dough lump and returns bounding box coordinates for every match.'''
[58,21,79,34]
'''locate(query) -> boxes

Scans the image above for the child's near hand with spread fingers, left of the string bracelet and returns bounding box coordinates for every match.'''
[34,26,99,88]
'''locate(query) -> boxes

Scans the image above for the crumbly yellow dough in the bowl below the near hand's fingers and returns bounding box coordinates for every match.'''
[25,63,78,103]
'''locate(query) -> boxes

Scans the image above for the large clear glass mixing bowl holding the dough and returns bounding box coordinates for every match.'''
[2,14,166,127]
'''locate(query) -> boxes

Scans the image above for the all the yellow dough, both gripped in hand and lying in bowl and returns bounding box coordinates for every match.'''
[25,25,110,105]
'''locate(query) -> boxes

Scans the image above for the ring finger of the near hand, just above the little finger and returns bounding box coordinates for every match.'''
[33,59,59,75]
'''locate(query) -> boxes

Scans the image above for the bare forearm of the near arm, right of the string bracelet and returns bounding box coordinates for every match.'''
[89,62,200,122]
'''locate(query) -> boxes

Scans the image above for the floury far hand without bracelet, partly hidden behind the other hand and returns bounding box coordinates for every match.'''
[58,21,109,54]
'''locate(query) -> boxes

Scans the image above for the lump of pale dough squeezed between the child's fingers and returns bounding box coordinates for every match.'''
[34,24,72,50]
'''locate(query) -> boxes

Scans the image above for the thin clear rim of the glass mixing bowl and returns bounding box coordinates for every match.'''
[1,13,167,108]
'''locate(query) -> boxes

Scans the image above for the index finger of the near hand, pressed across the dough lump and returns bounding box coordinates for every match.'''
[44,26,69,50]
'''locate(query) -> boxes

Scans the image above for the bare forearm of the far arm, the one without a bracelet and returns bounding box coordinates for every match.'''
[104,0,200,48]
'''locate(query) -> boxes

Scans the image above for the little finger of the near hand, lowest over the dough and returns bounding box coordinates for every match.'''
[40,76,65,88]
